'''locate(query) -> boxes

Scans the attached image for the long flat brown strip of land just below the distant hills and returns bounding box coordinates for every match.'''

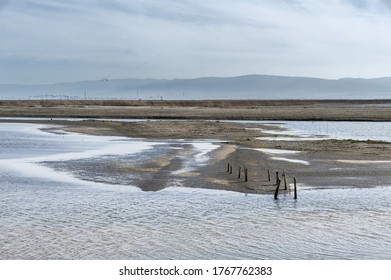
[0,100,391,121]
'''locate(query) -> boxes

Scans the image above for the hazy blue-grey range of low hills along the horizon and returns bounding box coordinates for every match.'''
[0,75,391,100]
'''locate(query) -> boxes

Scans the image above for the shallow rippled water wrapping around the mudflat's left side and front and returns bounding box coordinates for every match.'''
[0,124,391,259]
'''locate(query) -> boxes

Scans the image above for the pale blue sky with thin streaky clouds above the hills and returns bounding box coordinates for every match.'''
[0,0,391,83]
